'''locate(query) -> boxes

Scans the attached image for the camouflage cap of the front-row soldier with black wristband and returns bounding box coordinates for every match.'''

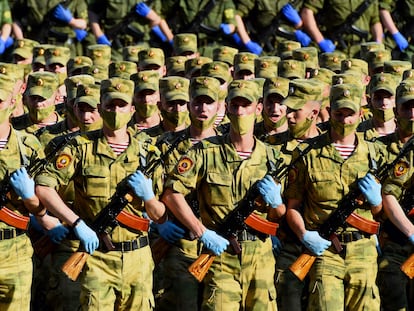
[100,77,134,103]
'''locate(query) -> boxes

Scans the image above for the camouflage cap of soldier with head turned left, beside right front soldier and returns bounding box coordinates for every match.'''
[283,79,323,110]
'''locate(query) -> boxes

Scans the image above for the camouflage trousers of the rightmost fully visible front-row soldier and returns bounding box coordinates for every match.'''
[308,236,380,311]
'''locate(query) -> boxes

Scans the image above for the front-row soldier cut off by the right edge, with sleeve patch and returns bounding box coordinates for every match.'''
[378,81,414,310]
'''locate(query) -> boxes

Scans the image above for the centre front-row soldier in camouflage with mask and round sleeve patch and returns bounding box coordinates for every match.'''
[163,80,285,310]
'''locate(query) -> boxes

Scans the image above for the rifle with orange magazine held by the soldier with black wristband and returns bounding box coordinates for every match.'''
[62,136,186,281]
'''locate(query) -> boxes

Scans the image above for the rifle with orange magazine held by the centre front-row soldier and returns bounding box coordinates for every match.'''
[188,143,313,282]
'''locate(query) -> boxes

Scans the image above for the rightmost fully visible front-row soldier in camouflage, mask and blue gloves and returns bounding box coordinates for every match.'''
[285,84,384,310]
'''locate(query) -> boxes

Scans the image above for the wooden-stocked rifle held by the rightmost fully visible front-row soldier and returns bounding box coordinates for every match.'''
[289,137,414,281]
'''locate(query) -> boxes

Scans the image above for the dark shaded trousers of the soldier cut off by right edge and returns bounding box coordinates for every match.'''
[377,241,414,311]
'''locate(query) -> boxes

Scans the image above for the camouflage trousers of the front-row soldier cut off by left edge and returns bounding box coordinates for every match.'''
[0,234,33,311]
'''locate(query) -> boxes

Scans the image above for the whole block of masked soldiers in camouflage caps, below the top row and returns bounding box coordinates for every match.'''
[0,34,414,311]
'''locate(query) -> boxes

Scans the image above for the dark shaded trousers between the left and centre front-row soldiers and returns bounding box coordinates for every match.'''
[156,239,200,311]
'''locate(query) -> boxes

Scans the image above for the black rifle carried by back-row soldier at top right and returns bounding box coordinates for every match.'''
[329,0,374,50]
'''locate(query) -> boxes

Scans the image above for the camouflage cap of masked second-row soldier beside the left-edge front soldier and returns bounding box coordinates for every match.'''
[24,71,59,99]
